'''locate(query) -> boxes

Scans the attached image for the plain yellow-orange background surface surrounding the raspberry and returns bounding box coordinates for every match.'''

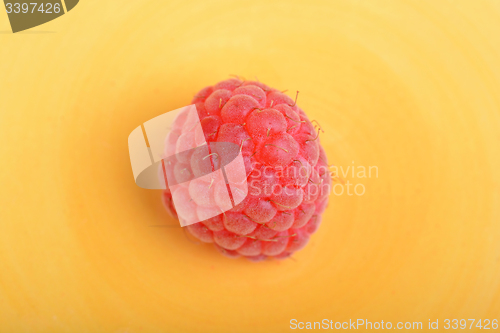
[0,0,500,332]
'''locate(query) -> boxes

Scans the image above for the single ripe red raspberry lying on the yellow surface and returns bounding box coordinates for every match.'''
[162,78,331,261]
